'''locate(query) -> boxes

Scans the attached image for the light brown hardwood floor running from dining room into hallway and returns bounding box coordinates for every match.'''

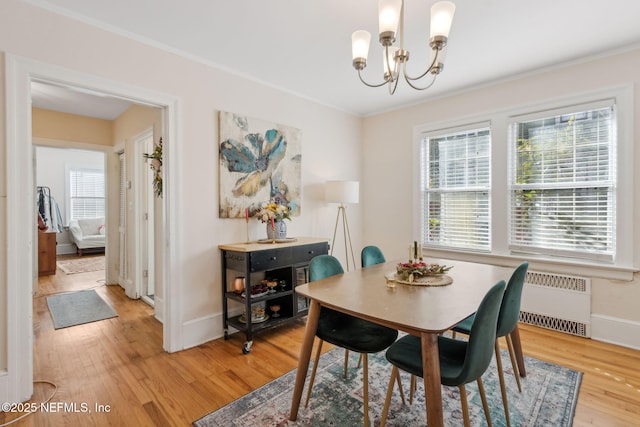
[0,260,640,427]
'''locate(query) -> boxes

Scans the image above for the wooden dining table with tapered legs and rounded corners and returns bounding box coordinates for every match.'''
[289,259,526,427]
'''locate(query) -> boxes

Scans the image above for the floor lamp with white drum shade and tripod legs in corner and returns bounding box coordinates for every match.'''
[325,181,360,271]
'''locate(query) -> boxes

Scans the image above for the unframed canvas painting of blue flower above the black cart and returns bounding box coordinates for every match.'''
[219,111,302,218]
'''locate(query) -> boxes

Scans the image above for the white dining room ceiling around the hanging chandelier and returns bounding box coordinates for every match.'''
[26,0,640,115]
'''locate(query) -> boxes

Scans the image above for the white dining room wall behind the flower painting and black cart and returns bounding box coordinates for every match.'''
[0,0,362,398]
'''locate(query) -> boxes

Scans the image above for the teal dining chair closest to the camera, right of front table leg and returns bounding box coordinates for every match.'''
[380,280,506,427]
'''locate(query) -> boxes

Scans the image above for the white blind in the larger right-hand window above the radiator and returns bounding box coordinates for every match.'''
[509,100,616,260]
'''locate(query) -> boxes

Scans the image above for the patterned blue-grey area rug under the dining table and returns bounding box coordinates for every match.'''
[193,348,582,427]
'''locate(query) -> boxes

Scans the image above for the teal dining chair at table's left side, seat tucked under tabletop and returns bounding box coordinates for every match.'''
[305,255,398,426]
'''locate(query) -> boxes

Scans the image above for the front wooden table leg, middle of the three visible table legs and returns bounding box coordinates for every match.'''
[420,332,444,427]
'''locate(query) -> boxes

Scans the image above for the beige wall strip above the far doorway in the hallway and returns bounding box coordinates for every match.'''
[31,108,113,145]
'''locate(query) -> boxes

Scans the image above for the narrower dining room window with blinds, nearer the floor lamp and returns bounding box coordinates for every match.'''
[420,124,491,250]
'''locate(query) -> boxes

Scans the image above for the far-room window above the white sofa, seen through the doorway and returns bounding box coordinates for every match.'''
[69,168,105,220]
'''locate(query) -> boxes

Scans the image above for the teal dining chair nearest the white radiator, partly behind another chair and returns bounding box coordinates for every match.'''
[453,261,529,426]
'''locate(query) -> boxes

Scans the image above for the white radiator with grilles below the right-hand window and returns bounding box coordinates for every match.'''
[520,271,591,337]
